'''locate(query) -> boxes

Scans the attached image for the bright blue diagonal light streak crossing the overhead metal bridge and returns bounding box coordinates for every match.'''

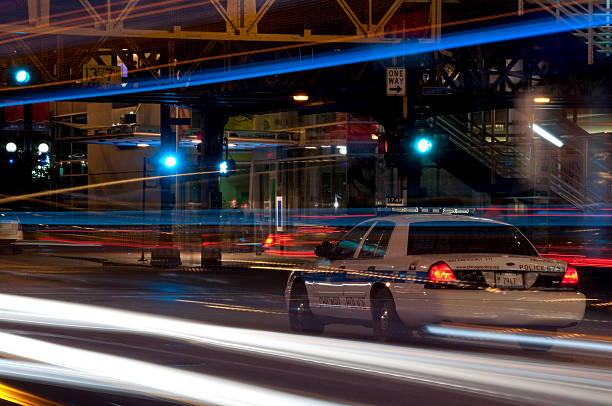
[0,16,605,107]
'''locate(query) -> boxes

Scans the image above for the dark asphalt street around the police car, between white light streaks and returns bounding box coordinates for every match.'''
[0,250,612,405]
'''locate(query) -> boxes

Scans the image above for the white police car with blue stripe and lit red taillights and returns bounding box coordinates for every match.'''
[285,208,586,341]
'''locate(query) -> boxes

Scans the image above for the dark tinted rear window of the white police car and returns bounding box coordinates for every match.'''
[408,221,538,256]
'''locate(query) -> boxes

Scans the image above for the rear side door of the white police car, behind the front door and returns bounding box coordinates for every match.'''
[343,221,395,320]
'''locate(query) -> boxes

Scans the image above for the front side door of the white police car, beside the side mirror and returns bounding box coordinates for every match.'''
[309,222,374,317]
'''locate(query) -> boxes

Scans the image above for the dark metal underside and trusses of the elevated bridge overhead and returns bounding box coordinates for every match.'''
[0,0,612,205]
